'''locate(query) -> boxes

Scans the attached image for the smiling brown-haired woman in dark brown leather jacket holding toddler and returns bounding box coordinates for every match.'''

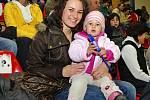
[0,0,135,100]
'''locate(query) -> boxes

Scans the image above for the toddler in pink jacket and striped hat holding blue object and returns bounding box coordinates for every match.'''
[68,11,126,100]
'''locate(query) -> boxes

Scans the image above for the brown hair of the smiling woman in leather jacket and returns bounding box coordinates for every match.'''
[48,0,88,28]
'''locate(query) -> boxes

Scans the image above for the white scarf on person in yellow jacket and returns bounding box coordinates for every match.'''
[12,1,32,23]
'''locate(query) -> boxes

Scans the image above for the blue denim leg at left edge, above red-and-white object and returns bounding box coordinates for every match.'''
[0,37,17,55]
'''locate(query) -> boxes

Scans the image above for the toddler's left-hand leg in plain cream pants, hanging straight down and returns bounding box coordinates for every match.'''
[68,74,90,100]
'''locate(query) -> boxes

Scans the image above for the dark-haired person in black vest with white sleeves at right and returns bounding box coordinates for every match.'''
[118,22,150,93]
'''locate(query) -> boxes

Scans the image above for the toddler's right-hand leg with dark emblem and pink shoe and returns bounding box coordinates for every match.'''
[96,76,126,100]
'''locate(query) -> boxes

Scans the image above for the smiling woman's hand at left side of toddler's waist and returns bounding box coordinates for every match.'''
[62,63,85,77]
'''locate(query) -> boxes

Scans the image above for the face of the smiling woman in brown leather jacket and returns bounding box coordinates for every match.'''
[62,0,83,28]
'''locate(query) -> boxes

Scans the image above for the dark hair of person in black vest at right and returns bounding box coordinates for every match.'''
[127,22,149,42]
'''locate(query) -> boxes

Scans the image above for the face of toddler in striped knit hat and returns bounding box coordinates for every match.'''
[85,20,102,37]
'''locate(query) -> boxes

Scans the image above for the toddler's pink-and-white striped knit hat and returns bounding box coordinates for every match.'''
[83,11,105,32]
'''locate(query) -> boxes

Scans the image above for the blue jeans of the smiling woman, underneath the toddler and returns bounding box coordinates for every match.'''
[55,80,136,100]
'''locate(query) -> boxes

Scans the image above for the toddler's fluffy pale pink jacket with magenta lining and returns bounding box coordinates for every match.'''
[68,32,120,70]
